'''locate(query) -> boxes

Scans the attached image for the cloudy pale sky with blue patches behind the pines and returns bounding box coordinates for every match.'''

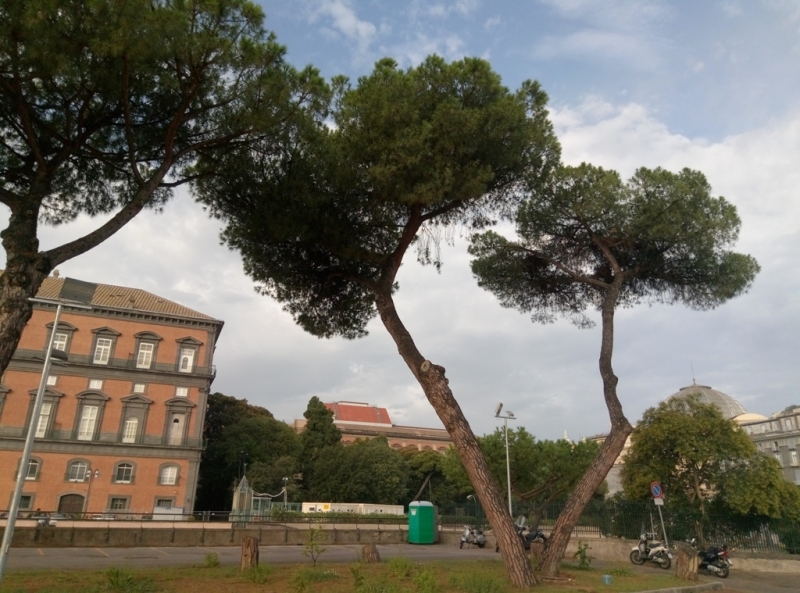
[0,0,800,439]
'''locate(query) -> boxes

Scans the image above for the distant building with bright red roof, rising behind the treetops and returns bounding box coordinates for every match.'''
[294,402,453,453]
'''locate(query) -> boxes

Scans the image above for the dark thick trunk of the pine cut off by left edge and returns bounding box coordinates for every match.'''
[0,199,52,374]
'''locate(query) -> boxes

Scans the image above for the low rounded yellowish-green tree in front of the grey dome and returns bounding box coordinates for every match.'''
[622,393,800,541]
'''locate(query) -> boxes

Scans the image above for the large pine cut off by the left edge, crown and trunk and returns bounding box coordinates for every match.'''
[0,0,316,373]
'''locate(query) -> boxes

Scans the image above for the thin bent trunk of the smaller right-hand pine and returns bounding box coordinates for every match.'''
[541,284,633,576]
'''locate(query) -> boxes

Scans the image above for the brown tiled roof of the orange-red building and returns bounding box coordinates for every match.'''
[36,276,218,321]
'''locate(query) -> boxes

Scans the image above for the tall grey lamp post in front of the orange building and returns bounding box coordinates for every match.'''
[0,278,97,584]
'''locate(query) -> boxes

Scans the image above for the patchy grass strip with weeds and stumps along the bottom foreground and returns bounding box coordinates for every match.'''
[0,559,686,593]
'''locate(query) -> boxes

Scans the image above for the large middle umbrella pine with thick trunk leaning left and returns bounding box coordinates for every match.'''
[198,57,559,587]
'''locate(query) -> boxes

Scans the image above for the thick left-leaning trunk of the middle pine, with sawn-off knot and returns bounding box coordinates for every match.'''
[375,291,537,588]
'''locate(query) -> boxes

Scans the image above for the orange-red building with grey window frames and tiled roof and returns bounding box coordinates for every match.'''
[0,277,223,518]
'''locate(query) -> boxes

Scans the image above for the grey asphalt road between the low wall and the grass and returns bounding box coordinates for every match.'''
[3,544,800,593]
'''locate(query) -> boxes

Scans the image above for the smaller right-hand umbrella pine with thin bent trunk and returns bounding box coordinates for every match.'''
[470,164,759,575]
